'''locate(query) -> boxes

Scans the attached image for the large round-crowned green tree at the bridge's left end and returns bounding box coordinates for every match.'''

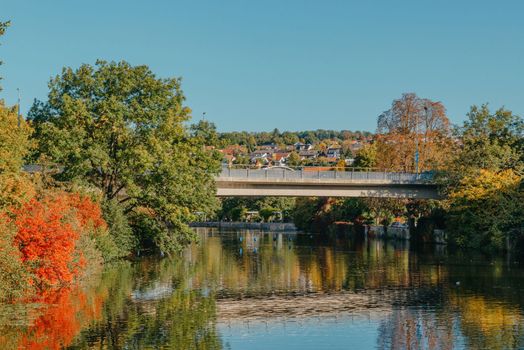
[29,61,220,252]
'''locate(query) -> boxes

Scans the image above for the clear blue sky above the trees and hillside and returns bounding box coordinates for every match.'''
[0,0,524,131]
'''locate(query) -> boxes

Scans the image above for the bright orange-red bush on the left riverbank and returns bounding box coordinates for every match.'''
[12,192,106,289]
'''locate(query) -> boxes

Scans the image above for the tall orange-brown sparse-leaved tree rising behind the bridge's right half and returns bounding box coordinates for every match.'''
[377,93,451,171]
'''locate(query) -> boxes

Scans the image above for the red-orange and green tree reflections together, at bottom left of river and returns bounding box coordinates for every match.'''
[0,259,221,349]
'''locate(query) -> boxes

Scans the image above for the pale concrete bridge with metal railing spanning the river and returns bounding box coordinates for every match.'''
[216,167,440,199]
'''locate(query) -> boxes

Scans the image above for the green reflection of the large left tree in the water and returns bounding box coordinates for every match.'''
[68,259,221,349]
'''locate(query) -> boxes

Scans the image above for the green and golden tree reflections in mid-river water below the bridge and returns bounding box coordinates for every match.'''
[190,232,446,296]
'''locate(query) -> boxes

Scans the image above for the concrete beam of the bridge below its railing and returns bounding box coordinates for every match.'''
[217,180,440,199]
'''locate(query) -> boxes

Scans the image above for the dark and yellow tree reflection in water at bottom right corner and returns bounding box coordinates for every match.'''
[447,255,524,349]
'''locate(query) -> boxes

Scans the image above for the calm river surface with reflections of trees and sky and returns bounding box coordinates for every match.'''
[0,229,524,350]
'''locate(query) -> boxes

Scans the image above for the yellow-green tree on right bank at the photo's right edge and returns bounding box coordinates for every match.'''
[438,105,524,250]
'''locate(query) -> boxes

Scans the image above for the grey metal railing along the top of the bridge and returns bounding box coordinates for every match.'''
[220,167,433,183]
